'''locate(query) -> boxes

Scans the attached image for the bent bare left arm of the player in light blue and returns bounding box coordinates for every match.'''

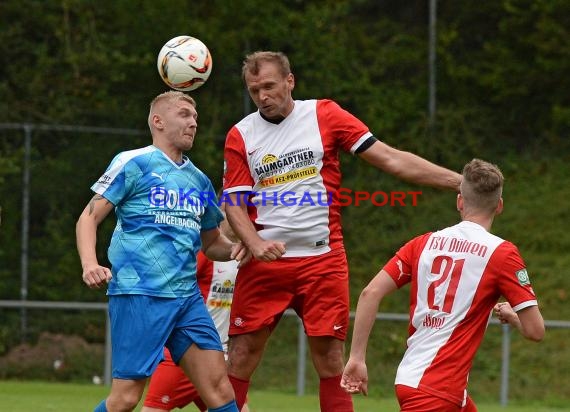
[75,194,115,288]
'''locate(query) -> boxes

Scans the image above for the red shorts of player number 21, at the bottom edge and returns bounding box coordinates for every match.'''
[396,385,477,412]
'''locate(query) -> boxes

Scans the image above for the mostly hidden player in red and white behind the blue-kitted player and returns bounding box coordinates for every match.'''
[141,203,249,412]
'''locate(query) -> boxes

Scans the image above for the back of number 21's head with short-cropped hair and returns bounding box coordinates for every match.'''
[459,159,505,212]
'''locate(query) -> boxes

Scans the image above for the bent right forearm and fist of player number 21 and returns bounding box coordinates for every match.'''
[493,302,545,342]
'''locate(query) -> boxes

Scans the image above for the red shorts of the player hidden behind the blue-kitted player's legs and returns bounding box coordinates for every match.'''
[144,348,207,411]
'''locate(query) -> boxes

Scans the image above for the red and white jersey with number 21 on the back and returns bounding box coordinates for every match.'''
[384,221,538,405]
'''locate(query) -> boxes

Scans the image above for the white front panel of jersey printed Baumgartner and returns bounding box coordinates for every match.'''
[234,100,330,257]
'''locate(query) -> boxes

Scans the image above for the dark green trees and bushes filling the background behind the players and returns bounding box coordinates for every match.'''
[0,0,570,402]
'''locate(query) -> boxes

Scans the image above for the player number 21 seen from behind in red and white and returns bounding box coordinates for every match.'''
[341,159,544,412]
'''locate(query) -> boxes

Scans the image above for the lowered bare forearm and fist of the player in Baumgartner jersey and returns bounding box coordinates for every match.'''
[222,193,285,262]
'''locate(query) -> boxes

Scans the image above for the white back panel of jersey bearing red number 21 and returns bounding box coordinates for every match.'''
[396,222,503,388]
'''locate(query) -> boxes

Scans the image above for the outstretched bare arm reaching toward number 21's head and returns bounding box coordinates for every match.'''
[359,141,462,191]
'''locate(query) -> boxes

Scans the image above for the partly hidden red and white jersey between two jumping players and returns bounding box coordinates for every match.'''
[196,251,238,353]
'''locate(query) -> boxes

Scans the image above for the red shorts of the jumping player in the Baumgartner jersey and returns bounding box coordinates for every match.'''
[229,249,350,340]
